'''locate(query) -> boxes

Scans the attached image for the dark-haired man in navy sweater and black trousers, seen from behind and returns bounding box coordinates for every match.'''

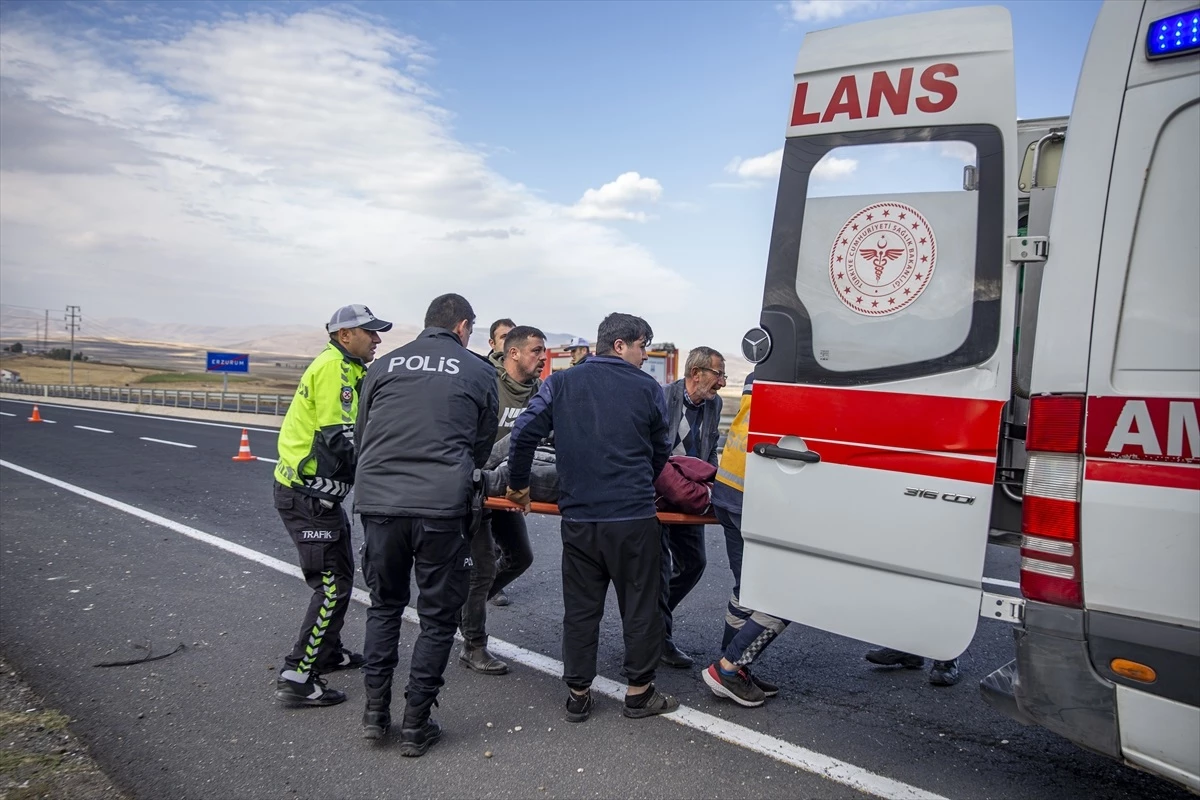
[508,314,679,722]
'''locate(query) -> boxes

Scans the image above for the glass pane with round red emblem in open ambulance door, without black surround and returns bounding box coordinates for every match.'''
[796,142,979,372]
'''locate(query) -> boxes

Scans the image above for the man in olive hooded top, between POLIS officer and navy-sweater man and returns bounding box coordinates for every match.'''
[458,325,546,675]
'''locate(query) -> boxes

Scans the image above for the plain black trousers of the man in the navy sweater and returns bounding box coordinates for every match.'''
[562,517,662,688]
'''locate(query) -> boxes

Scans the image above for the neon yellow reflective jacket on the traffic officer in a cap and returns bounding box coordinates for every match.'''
[275,342,367,501]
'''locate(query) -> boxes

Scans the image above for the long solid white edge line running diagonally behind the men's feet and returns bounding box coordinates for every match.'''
[0,459,946,800]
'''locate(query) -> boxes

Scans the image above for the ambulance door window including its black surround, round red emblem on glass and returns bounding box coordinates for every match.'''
[756,125,1004,386]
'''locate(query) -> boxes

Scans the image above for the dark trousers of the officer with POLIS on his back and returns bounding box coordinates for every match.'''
[362,516,472,705]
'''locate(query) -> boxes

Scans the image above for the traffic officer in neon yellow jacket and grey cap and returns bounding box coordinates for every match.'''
[275,305,391,705]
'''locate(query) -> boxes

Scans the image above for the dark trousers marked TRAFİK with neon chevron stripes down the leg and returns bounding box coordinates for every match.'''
[275,481,354,674]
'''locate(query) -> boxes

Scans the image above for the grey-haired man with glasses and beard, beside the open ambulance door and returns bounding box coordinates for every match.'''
[659,347,726,669]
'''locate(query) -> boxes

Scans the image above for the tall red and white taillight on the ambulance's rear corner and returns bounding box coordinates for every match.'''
[1021,395,1084,608]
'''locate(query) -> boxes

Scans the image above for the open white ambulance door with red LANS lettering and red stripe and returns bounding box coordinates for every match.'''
[742,7,1018,658]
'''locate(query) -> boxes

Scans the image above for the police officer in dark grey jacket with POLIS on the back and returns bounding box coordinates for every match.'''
[354,294,497,756]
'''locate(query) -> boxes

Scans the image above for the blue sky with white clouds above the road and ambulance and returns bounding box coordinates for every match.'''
[0,0,1099,353]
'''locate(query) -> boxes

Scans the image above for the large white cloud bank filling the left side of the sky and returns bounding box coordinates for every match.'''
[0,6,694,340]
